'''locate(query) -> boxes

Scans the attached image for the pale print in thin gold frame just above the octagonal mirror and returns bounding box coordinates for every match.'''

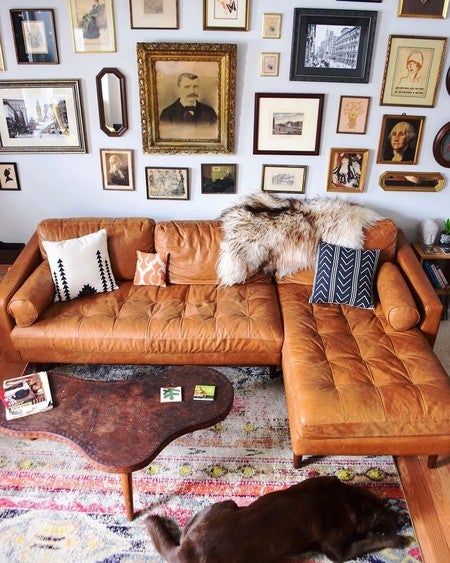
[69,0,116,53]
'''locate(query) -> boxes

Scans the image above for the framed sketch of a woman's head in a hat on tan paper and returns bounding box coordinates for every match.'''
[380,35,447,107]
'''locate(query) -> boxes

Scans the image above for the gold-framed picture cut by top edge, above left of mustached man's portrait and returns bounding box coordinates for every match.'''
[130,0,178,29]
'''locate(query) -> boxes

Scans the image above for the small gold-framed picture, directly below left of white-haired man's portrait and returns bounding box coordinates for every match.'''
[327,149,369,193]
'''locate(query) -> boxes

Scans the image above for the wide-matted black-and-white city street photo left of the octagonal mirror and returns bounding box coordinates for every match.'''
[0,80,87,153]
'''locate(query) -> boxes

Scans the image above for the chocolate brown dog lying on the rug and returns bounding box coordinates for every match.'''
[146,477,408,563]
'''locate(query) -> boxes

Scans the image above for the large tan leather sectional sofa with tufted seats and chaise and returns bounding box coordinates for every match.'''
[0,218,450,465]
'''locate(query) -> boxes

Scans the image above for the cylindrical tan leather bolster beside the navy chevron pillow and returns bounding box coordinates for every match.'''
[377,262,420,331]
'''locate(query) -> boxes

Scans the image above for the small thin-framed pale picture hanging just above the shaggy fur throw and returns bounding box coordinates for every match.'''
[261,164,307,194]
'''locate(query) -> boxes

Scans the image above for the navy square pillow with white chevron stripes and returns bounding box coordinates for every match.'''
[309,242,380,309]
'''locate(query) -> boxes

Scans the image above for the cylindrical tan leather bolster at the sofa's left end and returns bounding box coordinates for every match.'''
[8,261,55,326]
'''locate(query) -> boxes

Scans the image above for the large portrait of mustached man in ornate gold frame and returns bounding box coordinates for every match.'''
[137,43,236,153]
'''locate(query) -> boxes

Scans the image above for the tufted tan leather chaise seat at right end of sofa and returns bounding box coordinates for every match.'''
[278,284,450,440]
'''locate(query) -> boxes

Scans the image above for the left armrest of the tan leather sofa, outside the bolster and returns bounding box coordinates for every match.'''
[0,233,42,362]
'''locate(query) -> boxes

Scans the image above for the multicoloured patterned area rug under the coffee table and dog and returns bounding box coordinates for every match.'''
[0,365,422,563]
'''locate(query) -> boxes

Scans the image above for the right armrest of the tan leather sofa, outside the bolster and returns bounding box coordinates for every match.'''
[396,231,442,346]
